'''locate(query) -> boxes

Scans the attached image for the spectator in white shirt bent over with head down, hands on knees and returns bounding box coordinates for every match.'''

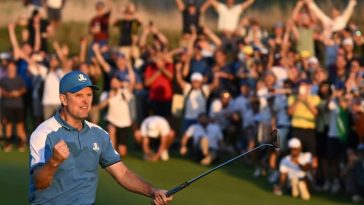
[134,115,175,161]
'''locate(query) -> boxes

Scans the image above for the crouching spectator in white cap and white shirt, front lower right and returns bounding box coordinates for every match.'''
[274,138,312,200]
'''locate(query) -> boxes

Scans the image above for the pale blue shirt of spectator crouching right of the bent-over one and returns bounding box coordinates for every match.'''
[186,123,223,150]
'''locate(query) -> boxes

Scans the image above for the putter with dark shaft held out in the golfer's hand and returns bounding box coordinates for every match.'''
[166,129,280,197]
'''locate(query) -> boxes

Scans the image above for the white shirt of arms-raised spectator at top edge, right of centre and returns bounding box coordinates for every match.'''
[217,3,243,32]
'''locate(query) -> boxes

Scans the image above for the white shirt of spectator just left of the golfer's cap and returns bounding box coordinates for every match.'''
[42,69,64,105]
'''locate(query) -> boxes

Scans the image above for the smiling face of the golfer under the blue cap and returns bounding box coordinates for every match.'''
[60,87,93,120]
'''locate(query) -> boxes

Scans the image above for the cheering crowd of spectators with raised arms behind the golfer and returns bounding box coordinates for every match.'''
[0,0,364,202]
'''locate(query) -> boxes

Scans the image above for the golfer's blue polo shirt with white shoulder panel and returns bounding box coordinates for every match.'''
[30,112,121,205]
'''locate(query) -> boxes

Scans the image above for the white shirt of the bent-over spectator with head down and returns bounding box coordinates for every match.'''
[140,116,171,138]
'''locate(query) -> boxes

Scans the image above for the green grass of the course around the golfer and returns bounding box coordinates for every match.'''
[0,151,351,205]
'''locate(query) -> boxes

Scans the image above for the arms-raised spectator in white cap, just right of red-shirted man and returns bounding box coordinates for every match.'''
[176,62,219,132]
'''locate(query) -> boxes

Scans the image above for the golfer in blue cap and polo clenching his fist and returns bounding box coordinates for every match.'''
[30,71,172,205]
